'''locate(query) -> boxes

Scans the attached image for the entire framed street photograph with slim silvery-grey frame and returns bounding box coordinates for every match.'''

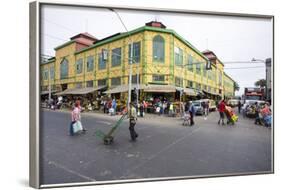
[30,1,274,188]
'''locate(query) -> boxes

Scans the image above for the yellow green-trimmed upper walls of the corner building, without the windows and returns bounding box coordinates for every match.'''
[41,26,234,99]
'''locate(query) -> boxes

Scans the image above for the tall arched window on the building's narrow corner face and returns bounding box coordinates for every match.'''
[153,35,165,62]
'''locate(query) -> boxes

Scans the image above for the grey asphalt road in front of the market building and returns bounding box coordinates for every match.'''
[40,110,272,184]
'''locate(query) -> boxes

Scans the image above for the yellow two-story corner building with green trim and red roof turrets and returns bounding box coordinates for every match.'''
[40,21,234,103]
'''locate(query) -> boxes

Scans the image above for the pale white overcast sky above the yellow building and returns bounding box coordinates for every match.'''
[41,5,273,95]
